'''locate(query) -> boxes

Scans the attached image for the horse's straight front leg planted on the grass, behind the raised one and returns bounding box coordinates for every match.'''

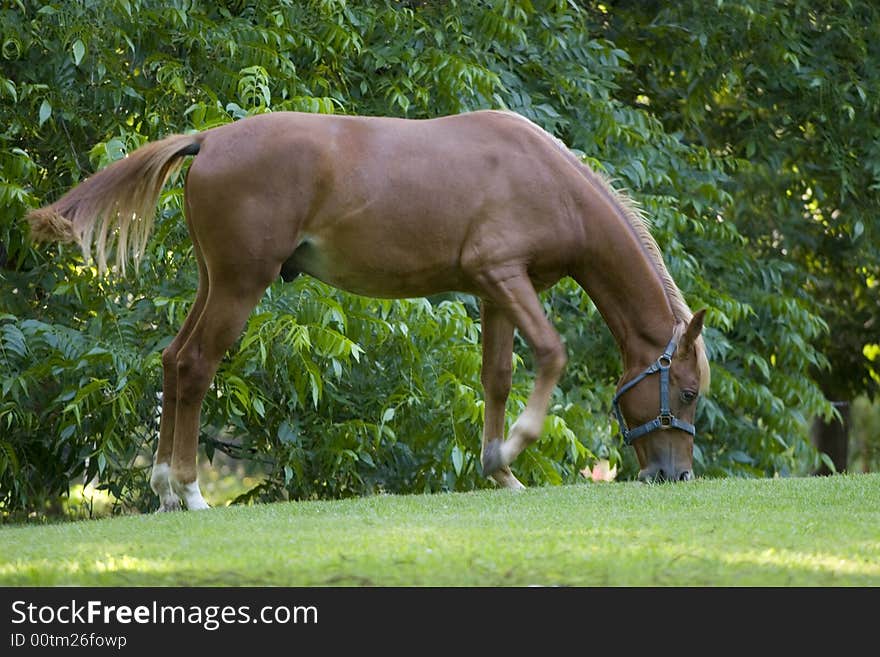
[480,299,525,489]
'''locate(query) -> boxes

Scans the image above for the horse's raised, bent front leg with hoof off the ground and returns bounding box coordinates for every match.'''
[480,270,566,474]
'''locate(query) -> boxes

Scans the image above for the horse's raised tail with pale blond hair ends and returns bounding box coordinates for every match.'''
[27,134,202,274]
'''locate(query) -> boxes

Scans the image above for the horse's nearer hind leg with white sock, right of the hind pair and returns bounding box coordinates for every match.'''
[171,264,278,509]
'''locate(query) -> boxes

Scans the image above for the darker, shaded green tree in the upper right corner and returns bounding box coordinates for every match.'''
[612,0,880,462]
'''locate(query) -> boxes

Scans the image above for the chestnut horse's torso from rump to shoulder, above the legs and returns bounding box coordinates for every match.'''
[187,111,583,296]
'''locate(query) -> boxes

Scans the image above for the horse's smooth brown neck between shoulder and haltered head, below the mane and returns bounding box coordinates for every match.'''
[574,204,676,369]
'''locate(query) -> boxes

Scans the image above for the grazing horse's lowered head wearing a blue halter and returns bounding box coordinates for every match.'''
[613,310,709,481]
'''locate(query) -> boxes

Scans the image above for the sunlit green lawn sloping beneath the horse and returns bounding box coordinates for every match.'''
[0,474,880,587]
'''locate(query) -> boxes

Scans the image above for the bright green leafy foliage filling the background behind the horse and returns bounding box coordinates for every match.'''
[0,0,878,514]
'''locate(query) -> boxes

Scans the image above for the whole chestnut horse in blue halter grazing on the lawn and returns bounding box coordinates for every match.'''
[28,111,709,510]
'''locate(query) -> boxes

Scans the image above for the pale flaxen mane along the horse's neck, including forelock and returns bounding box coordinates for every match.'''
[498,112,710,392]
